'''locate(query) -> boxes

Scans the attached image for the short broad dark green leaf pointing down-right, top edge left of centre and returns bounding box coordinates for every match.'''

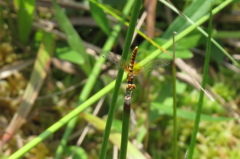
[89,0,111,35]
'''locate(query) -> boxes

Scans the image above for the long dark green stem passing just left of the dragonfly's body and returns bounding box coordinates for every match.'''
[99,0,141,159]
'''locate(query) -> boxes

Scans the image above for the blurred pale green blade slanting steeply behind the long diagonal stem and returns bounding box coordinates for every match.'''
[55,0,134,159]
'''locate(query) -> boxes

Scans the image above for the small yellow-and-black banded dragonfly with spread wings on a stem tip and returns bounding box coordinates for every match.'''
[102,46,170,95]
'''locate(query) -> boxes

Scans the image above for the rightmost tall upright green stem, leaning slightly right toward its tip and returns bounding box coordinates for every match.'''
[188,6,212,159]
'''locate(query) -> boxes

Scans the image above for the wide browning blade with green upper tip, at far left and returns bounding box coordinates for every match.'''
[2,33,54,148]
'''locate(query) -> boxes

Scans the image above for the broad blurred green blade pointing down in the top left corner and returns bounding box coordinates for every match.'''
[15,0,35,44]
